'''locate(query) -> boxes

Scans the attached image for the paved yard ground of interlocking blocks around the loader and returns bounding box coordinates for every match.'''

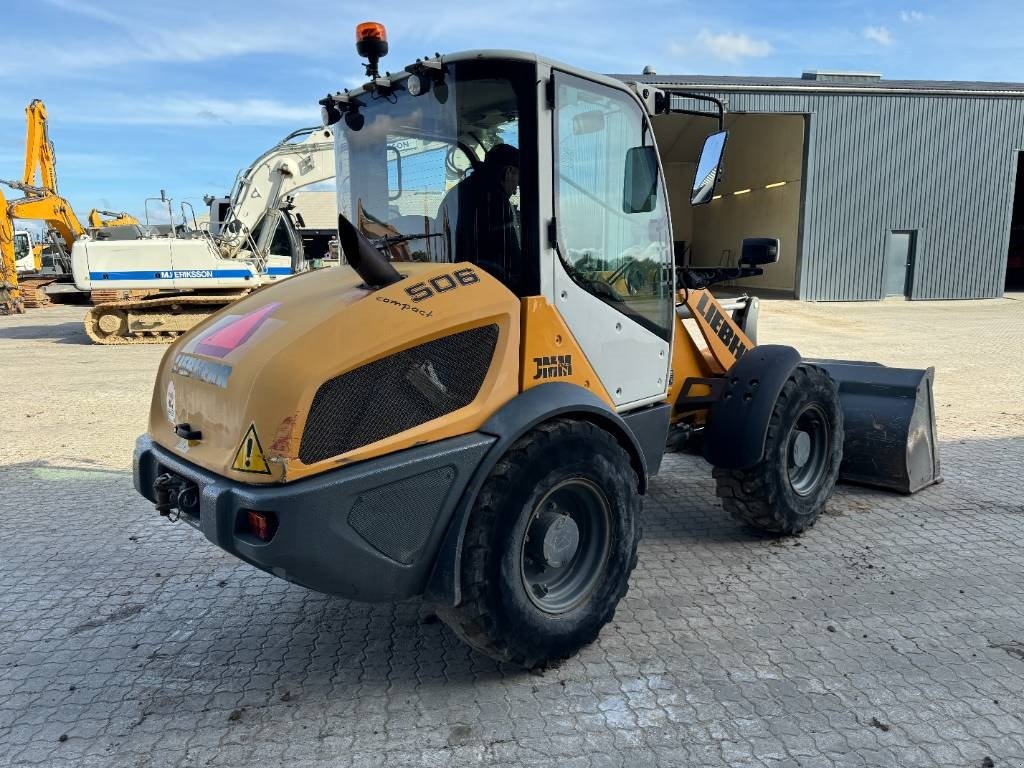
[0,297,1024,768]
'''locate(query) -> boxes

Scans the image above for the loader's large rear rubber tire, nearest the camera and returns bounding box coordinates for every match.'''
[438,420,642,669]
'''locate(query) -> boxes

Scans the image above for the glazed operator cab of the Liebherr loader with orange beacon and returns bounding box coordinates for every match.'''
[321,31,721,410]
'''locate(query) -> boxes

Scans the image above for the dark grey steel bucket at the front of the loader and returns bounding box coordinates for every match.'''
[813,360,942,494]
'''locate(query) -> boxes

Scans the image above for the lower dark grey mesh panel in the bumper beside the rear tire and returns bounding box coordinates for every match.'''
[348,467,455,565]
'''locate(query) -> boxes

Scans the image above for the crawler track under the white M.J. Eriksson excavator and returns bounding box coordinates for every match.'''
[85,291,249,344]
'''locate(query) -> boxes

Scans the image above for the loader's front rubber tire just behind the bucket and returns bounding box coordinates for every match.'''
[713,364,843,534]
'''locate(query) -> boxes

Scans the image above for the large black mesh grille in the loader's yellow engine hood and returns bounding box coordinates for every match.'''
[299,325,498,464]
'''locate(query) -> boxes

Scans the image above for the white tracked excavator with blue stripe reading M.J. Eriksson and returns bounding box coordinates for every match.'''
[72,127,335,344]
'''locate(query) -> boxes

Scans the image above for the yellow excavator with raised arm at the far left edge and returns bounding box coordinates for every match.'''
[0,98,85,314]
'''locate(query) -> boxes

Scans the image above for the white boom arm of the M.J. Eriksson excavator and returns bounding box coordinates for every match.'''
[219,126,335,258]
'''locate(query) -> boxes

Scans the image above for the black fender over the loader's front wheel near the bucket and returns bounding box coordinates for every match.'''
[703,344,800,469]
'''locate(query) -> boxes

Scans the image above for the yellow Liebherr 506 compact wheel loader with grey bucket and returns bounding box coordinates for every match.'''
[134,30,937,667]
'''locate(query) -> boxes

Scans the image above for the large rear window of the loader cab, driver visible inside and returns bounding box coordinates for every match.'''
[335,61,537,295]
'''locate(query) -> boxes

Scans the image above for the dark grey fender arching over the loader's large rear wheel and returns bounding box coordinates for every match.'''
[424,382,651,605]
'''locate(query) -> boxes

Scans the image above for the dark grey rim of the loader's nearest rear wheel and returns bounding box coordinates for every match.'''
[519,478,611,613]
